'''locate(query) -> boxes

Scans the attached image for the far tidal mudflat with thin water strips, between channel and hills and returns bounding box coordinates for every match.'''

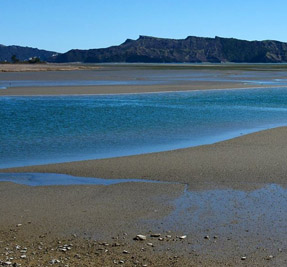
[0,64,287,96]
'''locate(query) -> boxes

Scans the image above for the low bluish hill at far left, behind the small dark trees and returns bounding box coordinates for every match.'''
[0,45,57,61]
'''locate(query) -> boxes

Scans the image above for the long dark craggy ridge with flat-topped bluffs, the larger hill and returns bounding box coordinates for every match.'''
[52,36,287,63]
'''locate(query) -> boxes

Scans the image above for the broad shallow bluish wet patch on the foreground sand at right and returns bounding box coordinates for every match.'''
[160,184,287,243]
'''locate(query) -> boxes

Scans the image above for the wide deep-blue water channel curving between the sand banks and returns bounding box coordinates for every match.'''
[0,88,287,168]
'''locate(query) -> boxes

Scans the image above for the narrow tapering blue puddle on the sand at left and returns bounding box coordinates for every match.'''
[0,173,164,186]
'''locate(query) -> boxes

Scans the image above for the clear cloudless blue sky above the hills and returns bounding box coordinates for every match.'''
[0,0,287,52]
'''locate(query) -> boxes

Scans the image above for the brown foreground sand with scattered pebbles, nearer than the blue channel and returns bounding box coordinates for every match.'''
[0,127,287,266]
